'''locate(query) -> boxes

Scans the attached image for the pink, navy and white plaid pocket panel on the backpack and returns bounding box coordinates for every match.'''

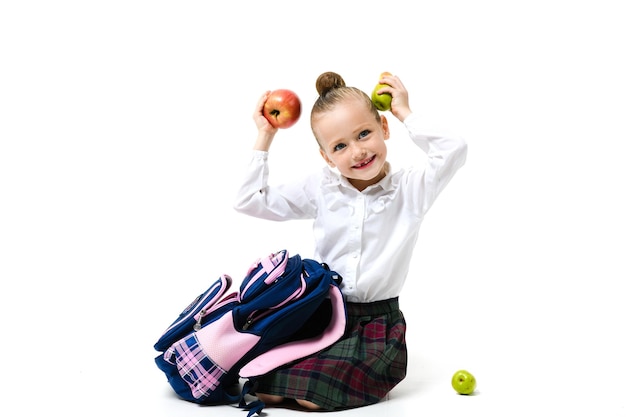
[164,333,226,400]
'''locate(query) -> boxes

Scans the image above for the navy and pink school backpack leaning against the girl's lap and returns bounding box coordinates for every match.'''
[154,250,346,416]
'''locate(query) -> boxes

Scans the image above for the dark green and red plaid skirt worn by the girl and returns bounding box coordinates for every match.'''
[256,298,407,410]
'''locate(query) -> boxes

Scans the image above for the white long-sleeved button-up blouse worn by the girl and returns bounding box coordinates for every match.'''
[234,114,467,302]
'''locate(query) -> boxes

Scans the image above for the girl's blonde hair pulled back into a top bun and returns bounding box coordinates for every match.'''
[311,71,381,144]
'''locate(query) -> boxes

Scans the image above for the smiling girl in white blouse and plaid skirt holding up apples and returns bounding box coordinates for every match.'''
[235,72,467,410]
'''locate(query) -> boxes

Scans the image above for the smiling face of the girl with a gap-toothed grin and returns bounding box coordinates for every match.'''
[315,101,389,191]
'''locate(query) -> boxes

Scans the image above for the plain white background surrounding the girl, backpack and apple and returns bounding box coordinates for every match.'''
[0,0,626,416]
